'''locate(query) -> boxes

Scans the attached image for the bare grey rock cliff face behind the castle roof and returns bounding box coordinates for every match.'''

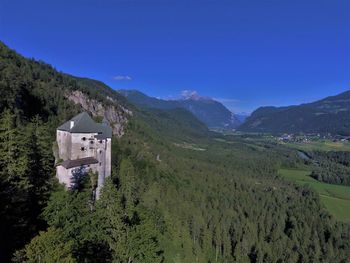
[66,90,132,137]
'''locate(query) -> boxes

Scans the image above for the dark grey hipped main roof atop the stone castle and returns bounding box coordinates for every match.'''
[57,112,112,139]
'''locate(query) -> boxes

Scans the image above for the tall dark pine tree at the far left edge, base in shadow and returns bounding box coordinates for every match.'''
[0,110,32,260]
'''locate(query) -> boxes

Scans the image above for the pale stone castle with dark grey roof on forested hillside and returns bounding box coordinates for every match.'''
[56,112,112,198]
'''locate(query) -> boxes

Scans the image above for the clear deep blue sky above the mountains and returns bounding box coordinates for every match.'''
[0,0,350,111]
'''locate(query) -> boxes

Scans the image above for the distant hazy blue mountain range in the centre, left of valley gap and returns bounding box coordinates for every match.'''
[119,90,241,129]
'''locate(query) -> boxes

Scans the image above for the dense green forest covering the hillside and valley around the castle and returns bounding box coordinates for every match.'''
[0,44,350,263]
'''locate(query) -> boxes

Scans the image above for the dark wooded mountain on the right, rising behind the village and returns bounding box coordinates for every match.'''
[239,91,350,135]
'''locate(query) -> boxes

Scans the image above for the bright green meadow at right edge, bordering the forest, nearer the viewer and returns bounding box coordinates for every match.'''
[279,169,350,222]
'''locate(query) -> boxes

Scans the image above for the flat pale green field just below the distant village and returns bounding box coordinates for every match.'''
[285,140,350,151]
